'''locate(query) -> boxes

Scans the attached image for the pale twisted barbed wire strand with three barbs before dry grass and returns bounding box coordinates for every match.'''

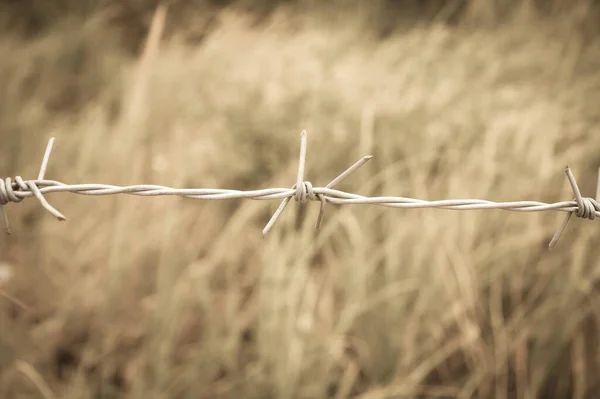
[0,130,600,249]
